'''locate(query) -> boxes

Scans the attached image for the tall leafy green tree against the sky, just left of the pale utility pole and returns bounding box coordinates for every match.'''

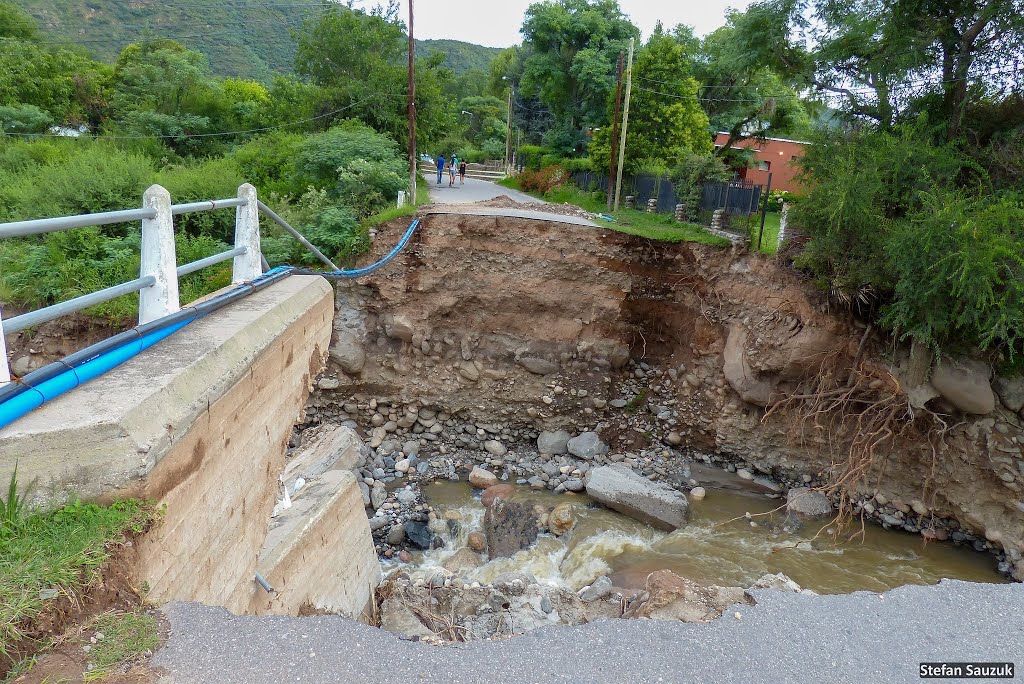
[520,0,640,144]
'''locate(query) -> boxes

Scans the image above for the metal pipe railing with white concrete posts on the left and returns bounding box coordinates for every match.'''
[0,183,264,386]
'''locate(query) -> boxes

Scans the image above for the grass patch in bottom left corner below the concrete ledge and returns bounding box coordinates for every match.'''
[0,493,157,659]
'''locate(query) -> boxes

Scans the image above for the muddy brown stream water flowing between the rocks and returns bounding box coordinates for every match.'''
[416,482,1004,594]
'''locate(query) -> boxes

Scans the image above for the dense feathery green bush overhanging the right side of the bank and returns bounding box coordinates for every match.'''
[791,126,1024,360]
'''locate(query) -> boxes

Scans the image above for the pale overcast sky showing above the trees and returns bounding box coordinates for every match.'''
[389,0,750,47]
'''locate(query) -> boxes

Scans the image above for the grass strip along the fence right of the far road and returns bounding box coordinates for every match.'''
[499,178,730,247]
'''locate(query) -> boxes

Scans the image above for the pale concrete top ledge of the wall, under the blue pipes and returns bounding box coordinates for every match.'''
[0,276,333,500]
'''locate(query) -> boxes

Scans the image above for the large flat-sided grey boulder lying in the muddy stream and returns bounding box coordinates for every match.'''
[587,464,687,530]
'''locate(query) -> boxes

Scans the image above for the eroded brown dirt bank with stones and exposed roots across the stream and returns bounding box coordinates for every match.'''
[306,206,1024,580]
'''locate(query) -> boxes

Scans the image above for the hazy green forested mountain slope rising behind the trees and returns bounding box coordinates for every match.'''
[17,0,501,81]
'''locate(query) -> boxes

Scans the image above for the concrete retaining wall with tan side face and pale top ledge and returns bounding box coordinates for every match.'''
[0,276,376,612]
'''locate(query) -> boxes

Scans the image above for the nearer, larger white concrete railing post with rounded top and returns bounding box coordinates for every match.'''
[138,185,181,326]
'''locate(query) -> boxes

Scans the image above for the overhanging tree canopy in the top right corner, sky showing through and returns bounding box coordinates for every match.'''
[736,0,1024,140]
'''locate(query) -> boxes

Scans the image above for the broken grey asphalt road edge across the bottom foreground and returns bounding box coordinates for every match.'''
[154,582,1024,684]
